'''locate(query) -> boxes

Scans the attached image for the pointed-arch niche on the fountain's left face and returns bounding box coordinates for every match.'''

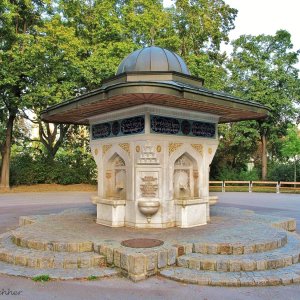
[104,153,126,200]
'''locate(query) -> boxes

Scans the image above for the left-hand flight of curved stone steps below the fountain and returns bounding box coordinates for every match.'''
[0,232,117,279]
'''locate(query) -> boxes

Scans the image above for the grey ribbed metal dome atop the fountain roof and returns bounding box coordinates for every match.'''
[116,46,191,75]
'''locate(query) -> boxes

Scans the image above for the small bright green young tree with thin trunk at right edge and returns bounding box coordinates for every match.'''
[281,125,300,182]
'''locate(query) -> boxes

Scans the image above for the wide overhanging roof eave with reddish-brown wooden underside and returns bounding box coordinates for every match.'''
[42,83,268,125]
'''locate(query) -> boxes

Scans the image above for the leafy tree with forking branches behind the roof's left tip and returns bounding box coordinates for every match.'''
[24,15,85,160]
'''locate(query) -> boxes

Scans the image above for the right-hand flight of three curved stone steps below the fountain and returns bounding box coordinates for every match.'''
[160,232,300,286]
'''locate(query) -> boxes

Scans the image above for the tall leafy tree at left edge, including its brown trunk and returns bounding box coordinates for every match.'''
[0,0,47,188]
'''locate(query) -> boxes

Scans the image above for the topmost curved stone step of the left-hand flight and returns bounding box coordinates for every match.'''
[12,231,94,252]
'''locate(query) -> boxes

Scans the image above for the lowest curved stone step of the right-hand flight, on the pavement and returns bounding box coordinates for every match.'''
[160,264,300,287]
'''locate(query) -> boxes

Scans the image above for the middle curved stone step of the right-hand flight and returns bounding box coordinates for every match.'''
[177,233,300,272]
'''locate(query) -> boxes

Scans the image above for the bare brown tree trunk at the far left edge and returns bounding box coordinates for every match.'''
[0,113,16,190]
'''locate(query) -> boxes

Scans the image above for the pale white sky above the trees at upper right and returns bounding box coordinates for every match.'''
[164,0,300,69]
